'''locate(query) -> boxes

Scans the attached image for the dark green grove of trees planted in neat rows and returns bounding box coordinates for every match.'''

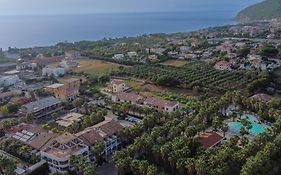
[122,62,251,92]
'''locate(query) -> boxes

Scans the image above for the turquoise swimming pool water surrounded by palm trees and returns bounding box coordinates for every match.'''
[228,115,267,135]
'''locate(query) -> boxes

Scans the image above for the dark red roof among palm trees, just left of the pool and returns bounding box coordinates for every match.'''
[198,131,224,149]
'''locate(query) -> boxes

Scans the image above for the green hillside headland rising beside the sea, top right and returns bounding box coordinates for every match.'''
[236,0,281,22]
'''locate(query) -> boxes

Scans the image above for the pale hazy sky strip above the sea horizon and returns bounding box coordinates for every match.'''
[0,0,260,15]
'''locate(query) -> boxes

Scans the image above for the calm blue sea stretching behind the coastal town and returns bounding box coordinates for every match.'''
[0,0,260,49]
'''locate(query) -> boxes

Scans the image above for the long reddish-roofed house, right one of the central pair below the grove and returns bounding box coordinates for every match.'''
[143,97,179,112]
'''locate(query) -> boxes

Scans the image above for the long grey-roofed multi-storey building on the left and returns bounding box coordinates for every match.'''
[20,97,63,120]
